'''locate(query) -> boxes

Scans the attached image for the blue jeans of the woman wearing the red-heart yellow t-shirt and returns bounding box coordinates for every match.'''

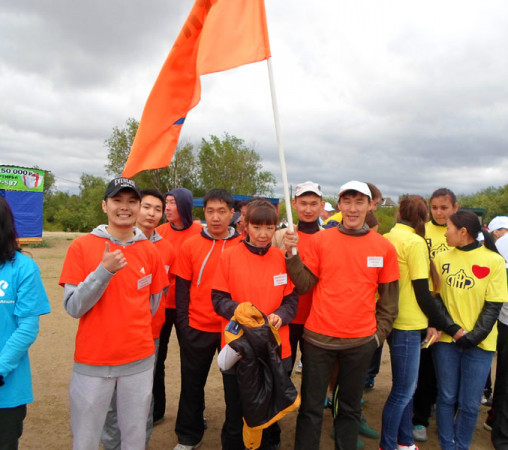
[433,342,495,450]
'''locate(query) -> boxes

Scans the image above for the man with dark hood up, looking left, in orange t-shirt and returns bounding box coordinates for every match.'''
[153,188,203,425]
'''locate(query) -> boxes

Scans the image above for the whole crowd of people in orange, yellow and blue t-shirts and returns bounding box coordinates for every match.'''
[0,178,508,450]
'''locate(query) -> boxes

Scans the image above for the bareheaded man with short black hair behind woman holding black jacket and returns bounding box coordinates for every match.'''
[171,189,240,448]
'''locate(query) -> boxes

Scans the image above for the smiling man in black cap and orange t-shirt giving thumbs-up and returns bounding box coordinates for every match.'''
[60,177,168,450]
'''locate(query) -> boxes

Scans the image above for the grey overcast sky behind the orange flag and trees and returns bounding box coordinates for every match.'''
[0,0,508,196]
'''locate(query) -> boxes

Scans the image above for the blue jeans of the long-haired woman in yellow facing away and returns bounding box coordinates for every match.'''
[380,329,421,450]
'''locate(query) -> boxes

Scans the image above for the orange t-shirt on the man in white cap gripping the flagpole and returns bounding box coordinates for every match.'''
[305,228,400,338]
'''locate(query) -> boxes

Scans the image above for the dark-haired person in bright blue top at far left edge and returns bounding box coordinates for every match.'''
[0,197,50,450]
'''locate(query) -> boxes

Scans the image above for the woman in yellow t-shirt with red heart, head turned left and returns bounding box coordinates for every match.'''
[433,210,508,450]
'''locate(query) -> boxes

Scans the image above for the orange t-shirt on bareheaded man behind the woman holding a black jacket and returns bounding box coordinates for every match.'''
[171,234,240,333]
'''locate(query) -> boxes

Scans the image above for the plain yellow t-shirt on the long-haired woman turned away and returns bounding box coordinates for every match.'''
[384,223,430,330]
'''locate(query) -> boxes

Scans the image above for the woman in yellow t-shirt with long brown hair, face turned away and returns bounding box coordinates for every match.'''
[380,195,453,450]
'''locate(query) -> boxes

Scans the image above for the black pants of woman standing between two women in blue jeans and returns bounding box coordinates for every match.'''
[413,331,437,427]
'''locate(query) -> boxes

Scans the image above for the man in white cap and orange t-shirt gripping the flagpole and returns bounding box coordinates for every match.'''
[285,181,400,450]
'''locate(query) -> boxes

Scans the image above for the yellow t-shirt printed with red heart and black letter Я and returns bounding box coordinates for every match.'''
[434,246,508,351]
